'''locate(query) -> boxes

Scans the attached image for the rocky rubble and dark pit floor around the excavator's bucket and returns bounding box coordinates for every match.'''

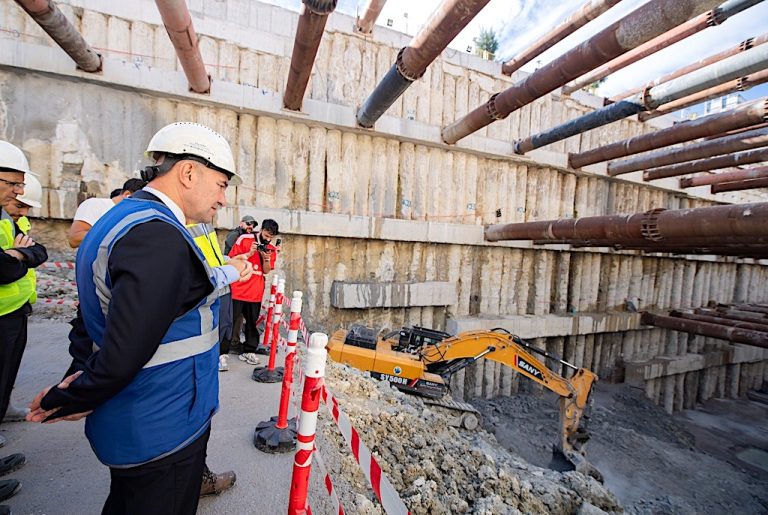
[318,364,768,514]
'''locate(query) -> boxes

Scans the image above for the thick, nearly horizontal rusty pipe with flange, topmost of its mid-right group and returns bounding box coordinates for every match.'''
[485,202,768,245]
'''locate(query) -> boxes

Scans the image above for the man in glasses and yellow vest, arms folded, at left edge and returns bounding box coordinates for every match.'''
[0,141,48,508]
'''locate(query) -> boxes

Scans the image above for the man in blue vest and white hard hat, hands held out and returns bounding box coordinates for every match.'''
[28,123,253,515]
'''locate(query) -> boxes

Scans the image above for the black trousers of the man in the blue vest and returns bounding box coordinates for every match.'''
[101,428,211,515]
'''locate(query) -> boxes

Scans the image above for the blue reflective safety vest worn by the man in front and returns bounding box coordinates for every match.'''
[75,198,219,468]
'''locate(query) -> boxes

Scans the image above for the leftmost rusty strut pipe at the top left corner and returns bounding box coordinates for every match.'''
[16,0,102,72]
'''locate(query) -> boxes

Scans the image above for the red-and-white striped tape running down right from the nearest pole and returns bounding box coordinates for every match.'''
[322,386,411,515]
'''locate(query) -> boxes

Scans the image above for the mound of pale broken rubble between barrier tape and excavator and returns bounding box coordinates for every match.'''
[318,363,622,514]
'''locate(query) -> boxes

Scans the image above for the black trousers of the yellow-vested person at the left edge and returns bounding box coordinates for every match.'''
[0,304,32,421]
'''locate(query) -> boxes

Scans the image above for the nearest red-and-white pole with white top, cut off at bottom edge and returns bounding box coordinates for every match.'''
[288,333,328,515]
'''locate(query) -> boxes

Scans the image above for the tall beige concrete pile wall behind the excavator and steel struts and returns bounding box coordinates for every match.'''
[0,0,768,407]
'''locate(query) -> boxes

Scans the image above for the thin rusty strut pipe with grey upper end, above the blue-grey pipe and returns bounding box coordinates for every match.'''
[563,0,763,95]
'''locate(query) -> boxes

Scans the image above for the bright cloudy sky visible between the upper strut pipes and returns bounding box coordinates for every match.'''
[267,0,768,115]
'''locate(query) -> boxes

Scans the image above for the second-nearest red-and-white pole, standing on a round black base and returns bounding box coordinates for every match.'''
[253,291,302,453]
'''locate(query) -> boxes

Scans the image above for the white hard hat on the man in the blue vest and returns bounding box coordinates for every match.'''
[147,122,243,186]
